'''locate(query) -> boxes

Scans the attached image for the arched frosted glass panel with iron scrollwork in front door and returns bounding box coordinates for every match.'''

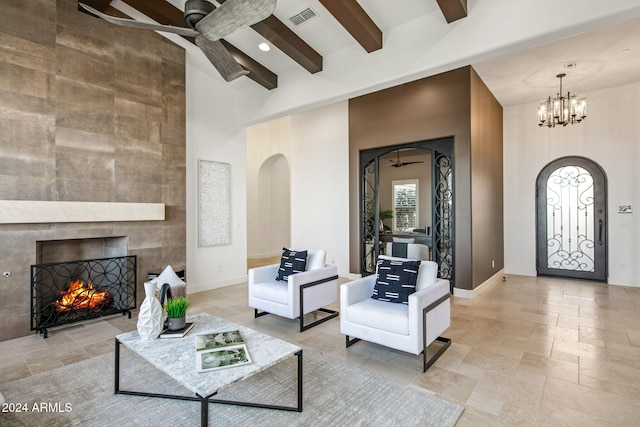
[547,166,595,272]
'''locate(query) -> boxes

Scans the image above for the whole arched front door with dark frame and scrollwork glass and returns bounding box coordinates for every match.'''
[536,157,607,282]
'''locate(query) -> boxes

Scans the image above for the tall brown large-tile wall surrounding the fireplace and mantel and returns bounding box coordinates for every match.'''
[0,0,186,341]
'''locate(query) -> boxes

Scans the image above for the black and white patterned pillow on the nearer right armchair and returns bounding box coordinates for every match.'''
[371,259,420,304]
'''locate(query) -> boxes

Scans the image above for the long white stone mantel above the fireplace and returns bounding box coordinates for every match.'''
[0,200,165,224]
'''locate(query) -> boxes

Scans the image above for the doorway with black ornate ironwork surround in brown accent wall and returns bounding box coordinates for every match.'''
[360,138,455,289]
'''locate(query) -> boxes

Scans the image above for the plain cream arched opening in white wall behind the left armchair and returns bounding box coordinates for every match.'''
[247,154,291,258]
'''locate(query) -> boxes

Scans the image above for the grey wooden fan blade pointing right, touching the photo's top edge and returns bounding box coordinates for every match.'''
[196,0,276,40]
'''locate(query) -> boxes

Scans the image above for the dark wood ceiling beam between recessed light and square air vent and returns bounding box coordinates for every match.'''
[218,0,322,74]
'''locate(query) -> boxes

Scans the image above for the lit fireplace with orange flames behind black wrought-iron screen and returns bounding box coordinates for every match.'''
[31,255,137,338]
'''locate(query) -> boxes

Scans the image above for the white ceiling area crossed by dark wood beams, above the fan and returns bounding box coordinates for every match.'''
[82,0,467,89]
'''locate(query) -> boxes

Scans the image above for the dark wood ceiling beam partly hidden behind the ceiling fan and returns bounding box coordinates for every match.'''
[111,0,278,89]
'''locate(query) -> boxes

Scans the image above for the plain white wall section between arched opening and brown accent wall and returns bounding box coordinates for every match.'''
[291,101,349,277]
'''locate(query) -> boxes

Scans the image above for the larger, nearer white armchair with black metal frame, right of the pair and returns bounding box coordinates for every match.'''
[340,255,451,371]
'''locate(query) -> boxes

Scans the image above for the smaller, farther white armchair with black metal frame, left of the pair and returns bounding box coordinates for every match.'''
[248,250,339,332]
